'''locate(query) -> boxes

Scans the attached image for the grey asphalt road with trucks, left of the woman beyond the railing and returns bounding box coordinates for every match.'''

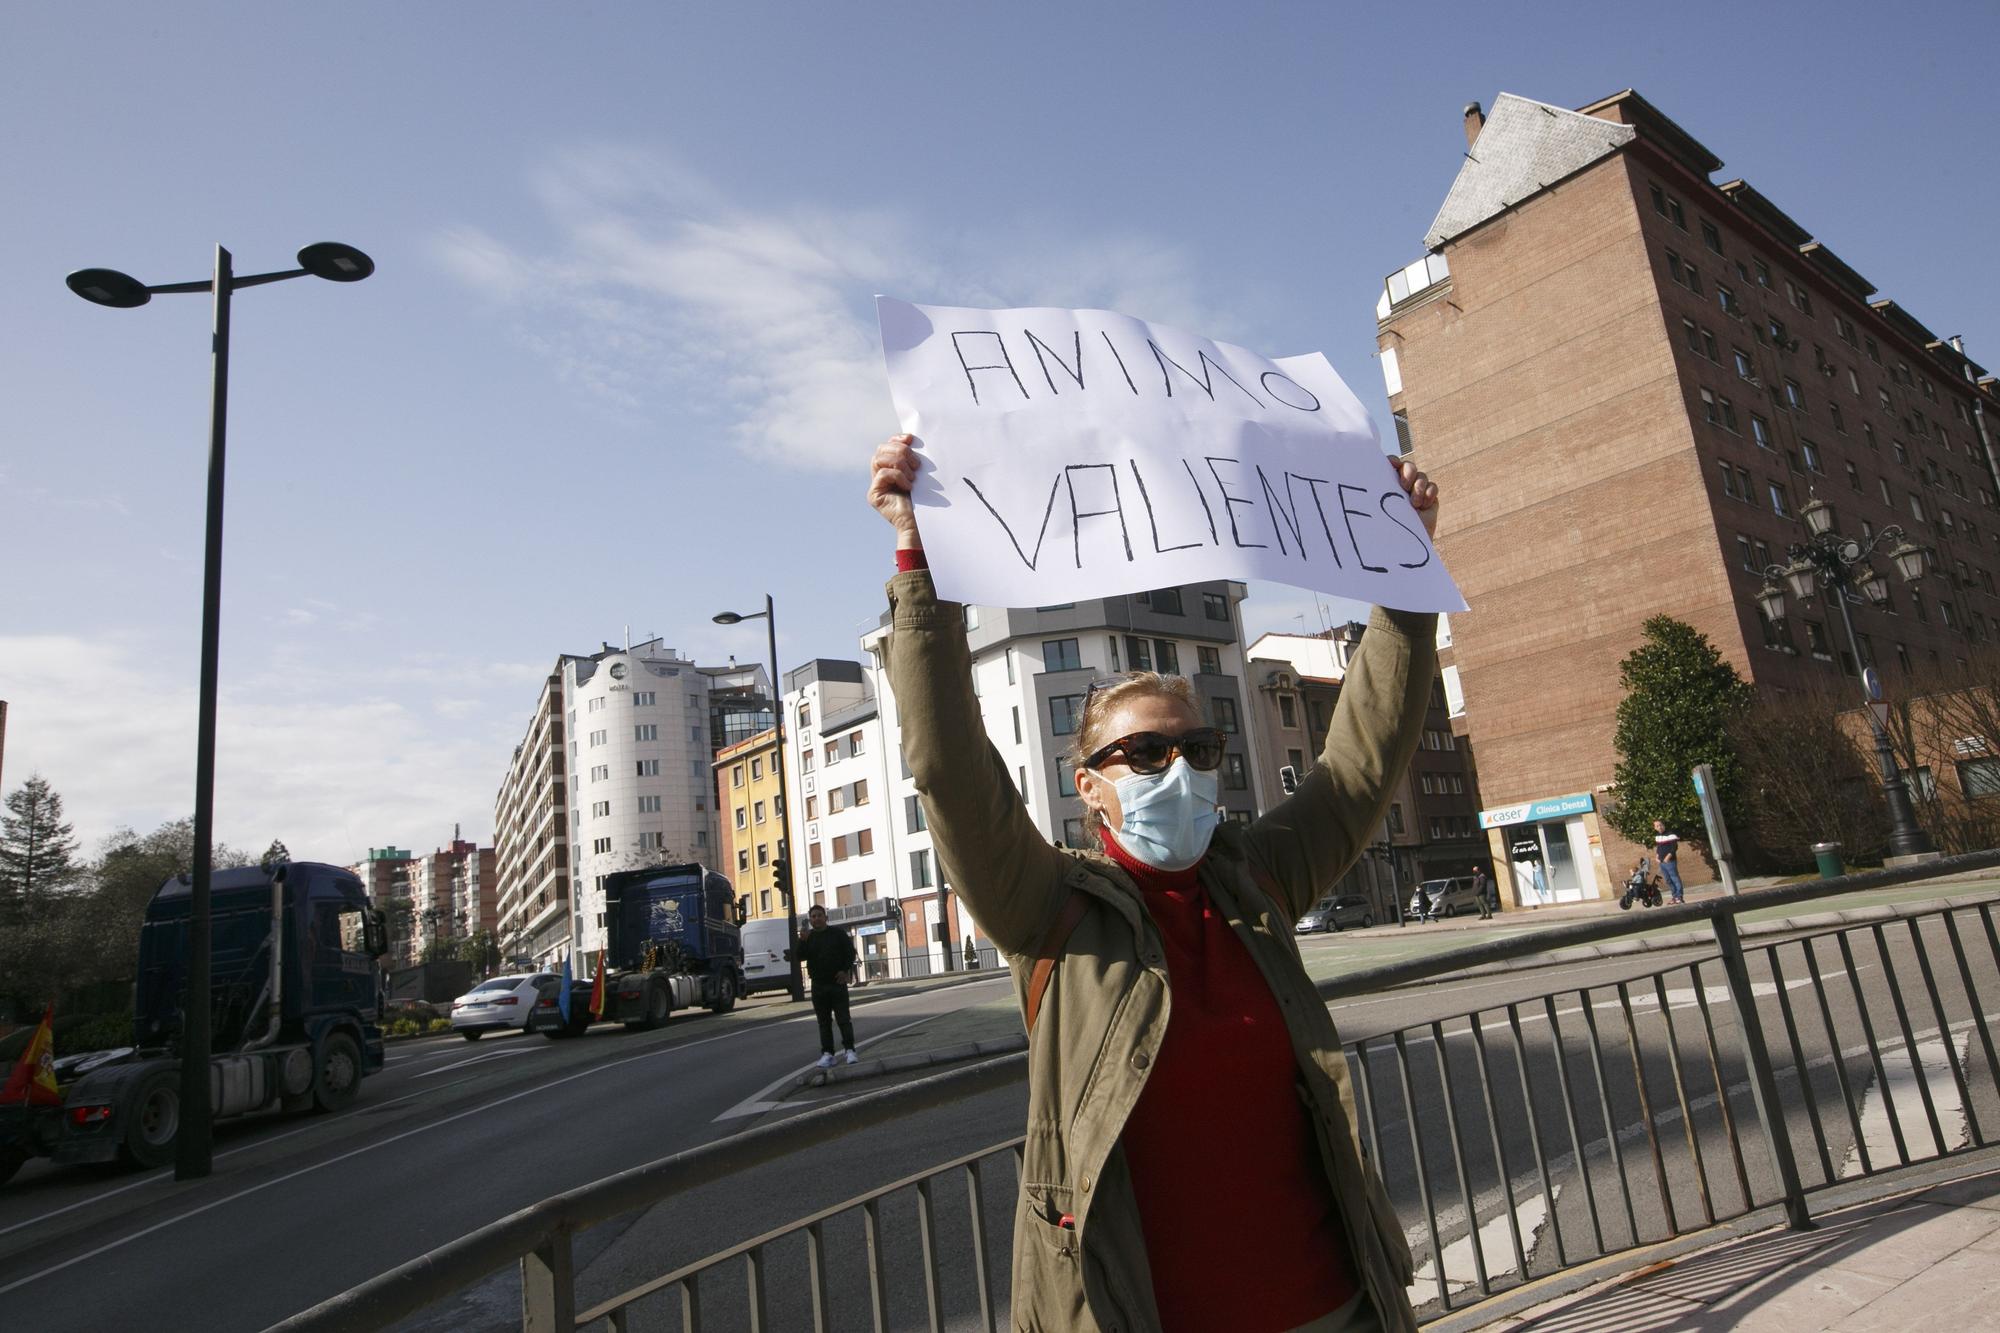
[0,964,1004,1333]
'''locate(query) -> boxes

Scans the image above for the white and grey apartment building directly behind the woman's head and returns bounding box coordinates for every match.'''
[848,580,1276,967]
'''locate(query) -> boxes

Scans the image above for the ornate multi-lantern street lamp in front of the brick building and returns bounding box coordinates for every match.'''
[1756,496,1938,857]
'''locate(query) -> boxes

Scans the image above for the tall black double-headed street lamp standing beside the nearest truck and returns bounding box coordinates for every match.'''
[64,240,374,1181]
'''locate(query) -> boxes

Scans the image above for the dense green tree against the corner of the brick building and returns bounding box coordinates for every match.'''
[1606,616,1752,845]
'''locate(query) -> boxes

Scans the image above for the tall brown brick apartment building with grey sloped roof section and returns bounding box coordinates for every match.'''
[1376,90,2000,903]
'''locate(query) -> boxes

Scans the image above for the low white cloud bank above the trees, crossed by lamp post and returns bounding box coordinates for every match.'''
[0,634,546,863]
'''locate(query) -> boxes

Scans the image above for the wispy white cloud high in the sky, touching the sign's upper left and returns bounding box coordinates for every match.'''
[434,146,1234,468]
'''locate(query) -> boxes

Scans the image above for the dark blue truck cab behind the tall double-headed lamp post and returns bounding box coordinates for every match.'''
[0,861,388,1181]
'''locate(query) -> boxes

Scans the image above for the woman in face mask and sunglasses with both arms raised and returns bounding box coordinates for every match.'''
[868,434,1438,1333]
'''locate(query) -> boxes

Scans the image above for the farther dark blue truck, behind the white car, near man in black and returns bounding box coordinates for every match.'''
[540,863,744,1037]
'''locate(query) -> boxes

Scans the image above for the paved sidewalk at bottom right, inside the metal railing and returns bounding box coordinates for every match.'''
[1480,1171,2000,1333]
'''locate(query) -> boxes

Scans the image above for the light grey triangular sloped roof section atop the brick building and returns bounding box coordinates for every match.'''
[1424,92,1638,250]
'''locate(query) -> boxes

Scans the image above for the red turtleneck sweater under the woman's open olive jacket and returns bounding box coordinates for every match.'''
[1104,831,1358,1333]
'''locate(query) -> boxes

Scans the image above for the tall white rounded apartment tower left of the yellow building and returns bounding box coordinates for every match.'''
[496,638,770,975]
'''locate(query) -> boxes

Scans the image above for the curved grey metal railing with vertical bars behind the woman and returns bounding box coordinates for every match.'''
[278,851,2000,1333]
